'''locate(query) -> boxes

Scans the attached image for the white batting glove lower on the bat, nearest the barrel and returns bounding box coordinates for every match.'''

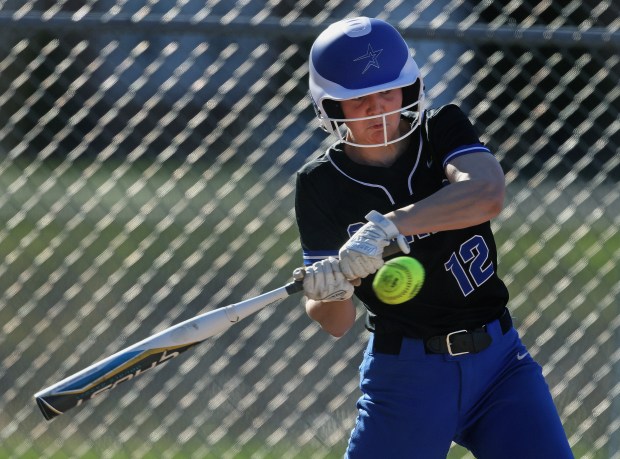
[304,257,353,301]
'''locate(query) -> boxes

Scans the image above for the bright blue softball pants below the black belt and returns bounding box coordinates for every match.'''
[345,321,573,459]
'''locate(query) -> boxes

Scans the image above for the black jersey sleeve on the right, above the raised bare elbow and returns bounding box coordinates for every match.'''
[427,104,491,168]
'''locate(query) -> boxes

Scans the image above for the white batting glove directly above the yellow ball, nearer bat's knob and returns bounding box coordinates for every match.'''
[338,210,410,280]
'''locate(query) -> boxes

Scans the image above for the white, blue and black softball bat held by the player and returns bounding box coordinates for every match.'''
[34,244,398,420]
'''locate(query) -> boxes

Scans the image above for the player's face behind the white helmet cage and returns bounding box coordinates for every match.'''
[340,88,403,145]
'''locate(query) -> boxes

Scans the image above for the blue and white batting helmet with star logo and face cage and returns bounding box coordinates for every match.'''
[309,17,424,147]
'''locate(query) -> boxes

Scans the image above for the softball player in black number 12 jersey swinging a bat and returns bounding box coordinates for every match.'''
[295,17,572,459]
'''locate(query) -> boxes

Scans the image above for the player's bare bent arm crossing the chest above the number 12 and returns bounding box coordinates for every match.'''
[386,154,505,235]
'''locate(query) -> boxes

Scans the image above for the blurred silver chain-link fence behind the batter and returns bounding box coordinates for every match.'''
[0,0,620,459]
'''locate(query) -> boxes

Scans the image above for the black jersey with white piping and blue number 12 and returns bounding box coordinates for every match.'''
[295,105,508,338]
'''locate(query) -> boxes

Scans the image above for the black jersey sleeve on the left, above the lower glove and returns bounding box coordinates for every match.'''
[295,168,342,266]
